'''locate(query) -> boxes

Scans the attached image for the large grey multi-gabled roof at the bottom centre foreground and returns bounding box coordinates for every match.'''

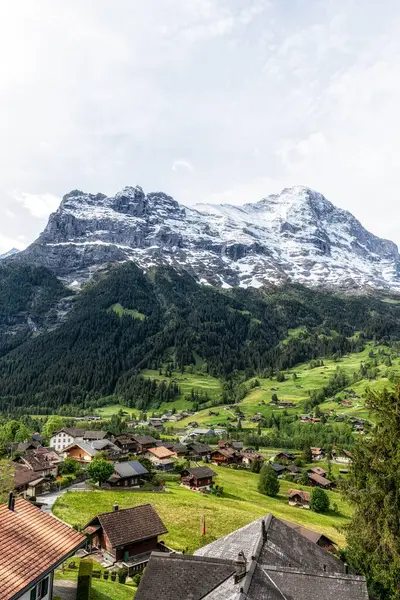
[135,515,368,600]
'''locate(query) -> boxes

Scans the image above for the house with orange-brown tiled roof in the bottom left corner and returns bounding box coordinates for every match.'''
[0,494,86,600]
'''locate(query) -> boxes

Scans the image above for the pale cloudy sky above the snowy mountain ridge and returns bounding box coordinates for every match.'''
[0,0,400,251]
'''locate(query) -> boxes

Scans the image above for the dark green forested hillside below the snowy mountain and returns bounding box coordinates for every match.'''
[0,263,400,410]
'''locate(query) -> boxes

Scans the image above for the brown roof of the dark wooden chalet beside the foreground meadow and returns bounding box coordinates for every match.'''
[85,504,168,548]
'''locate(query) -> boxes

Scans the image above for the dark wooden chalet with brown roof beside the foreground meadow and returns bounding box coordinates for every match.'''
[84,504,168,571]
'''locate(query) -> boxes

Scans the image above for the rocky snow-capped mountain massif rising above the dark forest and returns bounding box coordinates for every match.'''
[13,186,400,290]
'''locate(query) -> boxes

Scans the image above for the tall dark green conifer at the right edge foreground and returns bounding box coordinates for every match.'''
[344,386,400,600]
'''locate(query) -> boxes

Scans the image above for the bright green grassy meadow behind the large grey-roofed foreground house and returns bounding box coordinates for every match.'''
[53,466,350,552]
